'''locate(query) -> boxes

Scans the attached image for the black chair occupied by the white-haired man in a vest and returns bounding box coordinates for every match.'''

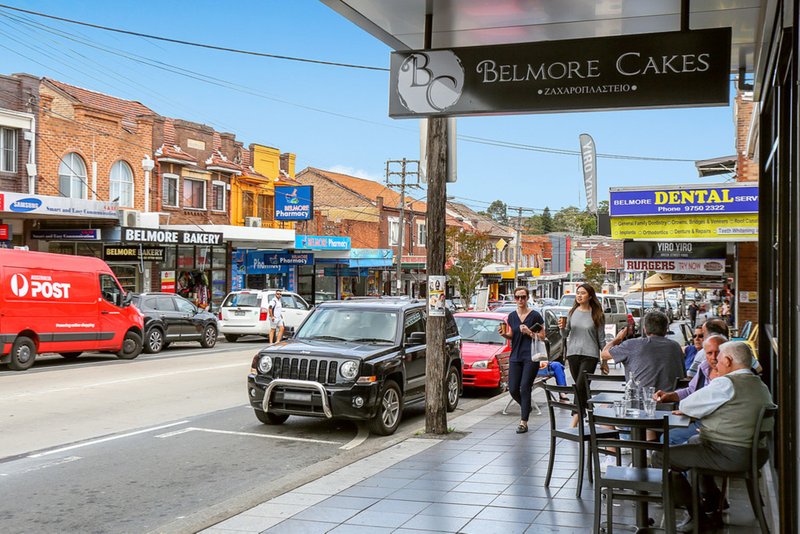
[691,407,778,534]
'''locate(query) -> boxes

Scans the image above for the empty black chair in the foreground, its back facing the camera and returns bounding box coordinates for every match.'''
[588,409,675,534]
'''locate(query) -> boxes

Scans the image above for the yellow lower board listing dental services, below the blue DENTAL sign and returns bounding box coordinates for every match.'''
[611,213,758,241]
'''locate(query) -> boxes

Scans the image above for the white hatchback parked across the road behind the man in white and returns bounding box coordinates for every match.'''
[218,289,311,342]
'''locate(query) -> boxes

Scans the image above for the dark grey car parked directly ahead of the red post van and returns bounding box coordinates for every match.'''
[133,293,219,354]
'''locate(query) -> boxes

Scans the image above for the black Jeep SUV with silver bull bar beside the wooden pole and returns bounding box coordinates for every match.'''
[247,299,462,435]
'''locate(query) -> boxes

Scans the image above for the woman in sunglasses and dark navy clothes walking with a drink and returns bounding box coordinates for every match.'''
[497,287,544,434]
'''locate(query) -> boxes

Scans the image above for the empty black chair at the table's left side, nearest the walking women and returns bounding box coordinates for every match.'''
[544,384,622,498]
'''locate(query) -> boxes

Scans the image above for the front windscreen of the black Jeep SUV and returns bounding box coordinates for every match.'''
[295,308,398,343]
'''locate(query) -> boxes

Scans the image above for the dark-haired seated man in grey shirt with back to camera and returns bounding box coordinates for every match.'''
[600,311,686,390]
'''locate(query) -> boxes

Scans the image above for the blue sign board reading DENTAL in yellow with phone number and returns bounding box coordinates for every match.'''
[609,184,758,217]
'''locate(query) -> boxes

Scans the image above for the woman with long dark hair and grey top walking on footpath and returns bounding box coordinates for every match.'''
[558,284,606,427]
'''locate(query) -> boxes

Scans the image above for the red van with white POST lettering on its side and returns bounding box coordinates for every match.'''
[0,249,144,371]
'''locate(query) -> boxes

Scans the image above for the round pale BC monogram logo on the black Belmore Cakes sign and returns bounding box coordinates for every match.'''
[397,50,464,113]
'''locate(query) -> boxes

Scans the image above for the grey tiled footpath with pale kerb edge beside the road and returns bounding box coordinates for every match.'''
[204,392,758,534]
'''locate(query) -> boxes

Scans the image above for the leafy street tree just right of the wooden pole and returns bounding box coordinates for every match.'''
[447,228,493,304]
